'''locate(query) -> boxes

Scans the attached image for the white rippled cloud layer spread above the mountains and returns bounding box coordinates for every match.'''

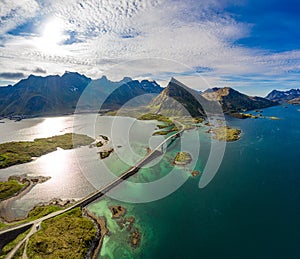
[0,0,300,95]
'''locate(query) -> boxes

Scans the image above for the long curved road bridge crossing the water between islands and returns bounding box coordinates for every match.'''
[0,125,184,258]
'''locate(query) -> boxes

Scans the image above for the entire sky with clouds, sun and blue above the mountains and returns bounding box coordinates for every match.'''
[0,0,300,96]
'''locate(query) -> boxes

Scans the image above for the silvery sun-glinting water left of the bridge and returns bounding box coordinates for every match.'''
[0,114,156,220]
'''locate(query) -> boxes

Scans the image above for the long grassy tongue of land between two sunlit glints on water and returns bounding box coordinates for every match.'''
[0,133,94,169]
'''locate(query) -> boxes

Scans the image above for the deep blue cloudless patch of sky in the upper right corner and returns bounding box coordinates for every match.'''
[225,0,300,52]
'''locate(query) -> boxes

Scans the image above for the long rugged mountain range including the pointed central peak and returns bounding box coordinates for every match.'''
[0,72,278,117]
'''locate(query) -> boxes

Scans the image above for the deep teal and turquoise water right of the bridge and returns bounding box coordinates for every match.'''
[89,106,300,258]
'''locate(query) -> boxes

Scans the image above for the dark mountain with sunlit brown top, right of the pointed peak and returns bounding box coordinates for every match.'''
[202,87,278,113]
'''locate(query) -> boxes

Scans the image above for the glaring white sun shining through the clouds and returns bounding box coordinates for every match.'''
[35,18,64,53]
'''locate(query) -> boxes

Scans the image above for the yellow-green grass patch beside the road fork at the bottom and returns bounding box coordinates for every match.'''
[27,208,97,258]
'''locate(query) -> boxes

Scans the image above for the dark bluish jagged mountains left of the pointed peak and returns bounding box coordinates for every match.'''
[0,72,162,116]
